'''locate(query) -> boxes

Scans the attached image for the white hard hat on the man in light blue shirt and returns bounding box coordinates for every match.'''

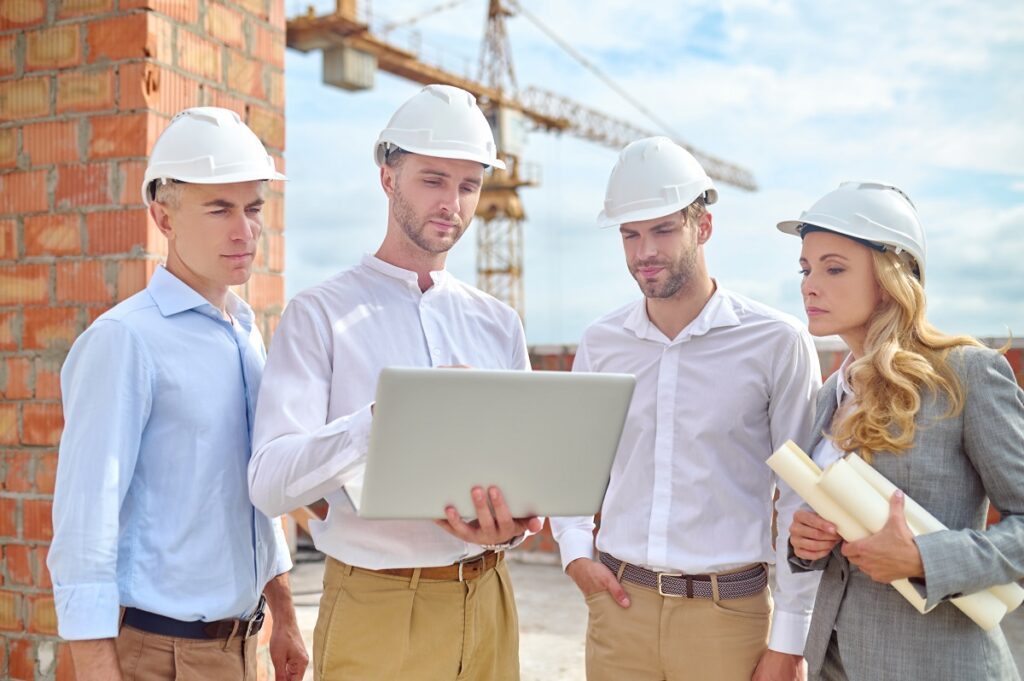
[142,107,287,206]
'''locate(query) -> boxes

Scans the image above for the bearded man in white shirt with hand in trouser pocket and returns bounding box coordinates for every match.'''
[551,137,821,681]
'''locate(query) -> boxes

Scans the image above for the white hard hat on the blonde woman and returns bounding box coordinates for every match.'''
[778,180,927,284]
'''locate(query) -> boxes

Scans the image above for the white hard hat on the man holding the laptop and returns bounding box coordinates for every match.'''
[374,85,505,170]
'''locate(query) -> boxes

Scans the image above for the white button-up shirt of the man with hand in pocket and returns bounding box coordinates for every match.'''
[551,288,821,654]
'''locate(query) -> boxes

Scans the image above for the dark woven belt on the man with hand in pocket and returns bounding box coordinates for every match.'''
[601,553,768,600]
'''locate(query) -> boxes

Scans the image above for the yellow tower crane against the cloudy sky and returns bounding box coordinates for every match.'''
[287,0,757,316]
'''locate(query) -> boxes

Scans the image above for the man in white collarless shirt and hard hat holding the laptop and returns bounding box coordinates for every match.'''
[249,85,540,681]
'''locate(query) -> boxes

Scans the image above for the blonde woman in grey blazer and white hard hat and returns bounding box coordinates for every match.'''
[778,182,1024,681]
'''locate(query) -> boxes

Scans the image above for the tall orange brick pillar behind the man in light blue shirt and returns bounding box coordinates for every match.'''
[0,0,285,680]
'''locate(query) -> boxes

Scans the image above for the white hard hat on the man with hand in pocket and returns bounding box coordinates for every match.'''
[597,137,718,227]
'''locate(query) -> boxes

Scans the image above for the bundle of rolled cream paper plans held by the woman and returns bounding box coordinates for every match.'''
[767,441,1020,631]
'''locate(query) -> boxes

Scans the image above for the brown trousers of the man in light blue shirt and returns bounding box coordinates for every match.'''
[117,627,259,681]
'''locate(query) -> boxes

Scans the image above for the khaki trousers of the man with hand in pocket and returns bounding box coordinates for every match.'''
[587,565,772,681]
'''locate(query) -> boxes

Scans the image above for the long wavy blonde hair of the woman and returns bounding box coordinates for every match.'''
[831,251,981,462]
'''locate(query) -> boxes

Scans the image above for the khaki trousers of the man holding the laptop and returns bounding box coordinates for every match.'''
[313,558,519,681]
